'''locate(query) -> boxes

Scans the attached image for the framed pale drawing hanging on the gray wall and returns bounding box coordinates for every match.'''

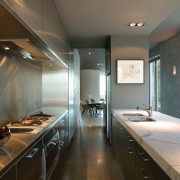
[116,59,144,84]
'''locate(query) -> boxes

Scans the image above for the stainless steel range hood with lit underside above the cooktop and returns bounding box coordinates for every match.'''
[0,2,67,68]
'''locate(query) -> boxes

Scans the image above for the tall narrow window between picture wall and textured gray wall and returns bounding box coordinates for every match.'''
[149,56,161,111]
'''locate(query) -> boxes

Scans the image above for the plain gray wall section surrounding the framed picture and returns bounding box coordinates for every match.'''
[111,35,149,108]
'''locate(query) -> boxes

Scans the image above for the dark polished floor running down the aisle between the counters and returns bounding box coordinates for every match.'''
[55,113,124,180]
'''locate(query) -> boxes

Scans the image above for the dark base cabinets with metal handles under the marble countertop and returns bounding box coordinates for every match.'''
[112,116,170,180]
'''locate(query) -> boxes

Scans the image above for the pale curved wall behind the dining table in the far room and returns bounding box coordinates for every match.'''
[80,69,100,101]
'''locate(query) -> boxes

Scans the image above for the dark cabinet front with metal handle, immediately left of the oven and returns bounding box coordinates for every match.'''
[17,141,42,180]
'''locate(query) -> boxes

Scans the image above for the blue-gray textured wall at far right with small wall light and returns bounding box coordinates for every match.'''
[151,34,180,118]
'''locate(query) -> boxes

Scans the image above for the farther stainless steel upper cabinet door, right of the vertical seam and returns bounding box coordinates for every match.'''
[42,0,69,63]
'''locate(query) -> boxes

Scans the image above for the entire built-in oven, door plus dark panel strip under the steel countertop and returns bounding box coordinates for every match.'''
[42,128,60,180]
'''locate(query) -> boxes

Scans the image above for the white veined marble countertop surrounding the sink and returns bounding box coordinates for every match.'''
[112,109,180,180]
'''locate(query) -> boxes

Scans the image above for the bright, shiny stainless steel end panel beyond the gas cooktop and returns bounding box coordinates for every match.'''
[42,69,68,109]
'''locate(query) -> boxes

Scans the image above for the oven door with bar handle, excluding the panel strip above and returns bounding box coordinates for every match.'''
[43,132,60,180]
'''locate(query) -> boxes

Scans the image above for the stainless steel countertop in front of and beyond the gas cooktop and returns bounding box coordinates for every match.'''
[0,107,68,179]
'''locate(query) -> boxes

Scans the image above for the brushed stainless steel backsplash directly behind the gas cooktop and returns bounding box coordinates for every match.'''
[0,51,42,125]
